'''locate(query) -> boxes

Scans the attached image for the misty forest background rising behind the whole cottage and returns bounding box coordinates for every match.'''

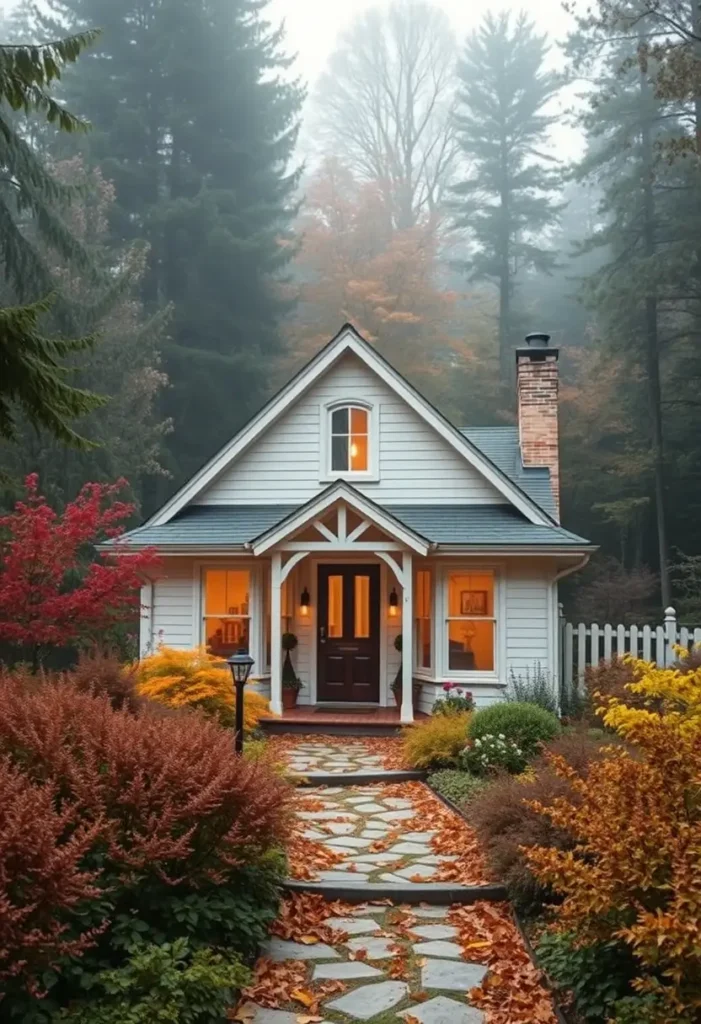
[0,0,701,623]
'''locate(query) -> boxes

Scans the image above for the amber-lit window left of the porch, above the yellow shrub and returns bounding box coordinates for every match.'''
[204,569,251,657]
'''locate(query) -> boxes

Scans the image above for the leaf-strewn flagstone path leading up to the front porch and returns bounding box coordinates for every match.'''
[232,737,556,1024]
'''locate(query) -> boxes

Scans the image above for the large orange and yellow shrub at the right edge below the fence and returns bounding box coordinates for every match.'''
[527,662,701,1024]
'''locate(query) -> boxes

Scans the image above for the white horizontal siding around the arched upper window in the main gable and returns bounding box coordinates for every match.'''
[196,354,506,505]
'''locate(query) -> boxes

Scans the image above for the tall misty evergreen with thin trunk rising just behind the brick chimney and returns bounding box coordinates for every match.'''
[453,12,560,382]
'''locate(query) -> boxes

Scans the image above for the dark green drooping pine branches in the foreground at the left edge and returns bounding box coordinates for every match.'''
[0,31,100,445]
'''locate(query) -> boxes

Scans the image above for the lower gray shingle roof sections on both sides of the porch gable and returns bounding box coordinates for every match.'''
[122,505,587,548]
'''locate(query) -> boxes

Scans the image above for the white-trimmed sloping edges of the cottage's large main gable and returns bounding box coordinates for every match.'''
[147,324,554,526]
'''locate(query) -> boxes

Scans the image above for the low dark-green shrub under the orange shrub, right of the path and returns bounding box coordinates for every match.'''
[536,932,637,1024]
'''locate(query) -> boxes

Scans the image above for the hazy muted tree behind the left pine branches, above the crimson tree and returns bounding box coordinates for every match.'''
[0,158,169,507]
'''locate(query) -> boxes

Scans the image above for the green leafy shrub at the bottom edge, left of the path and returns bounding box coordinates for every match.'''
[54,939,250,1024]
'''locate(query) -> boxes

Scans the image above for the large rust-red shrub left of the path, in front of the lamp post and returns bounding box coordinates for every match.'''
[0,676,289,883]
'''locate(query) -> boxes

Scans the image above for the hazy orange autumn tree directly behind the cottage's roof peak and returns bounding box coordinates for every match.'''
[291,158,496,419]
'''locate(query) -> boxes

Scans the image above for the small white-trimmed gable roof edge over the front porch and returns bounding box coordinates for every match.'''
[248,480,432,556]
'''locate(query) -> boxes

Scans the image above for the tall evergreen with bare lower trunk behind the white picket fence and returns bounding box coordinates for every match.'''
[570,8,698,607]
